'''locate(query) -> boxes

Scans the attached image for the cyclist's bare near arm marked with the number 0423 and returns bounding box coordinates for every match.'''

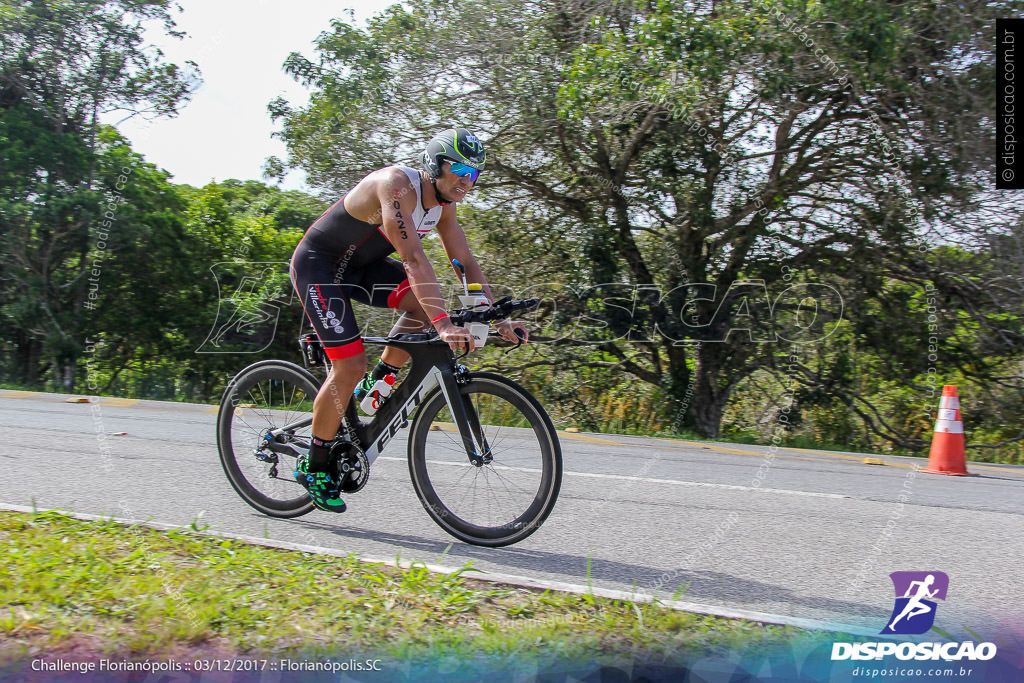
[378,176,451,332]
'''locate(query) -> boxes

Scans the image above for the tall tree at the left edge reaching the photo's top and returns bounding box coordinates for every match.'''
[0,0,198,390]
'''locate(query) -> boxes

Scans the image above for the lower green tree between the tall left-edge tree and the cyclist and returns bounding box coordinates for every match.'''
[75,174,324,400]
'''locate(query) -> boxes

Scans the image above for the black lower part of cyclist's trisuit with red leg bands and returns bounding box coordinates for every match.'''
[290,221,410,360]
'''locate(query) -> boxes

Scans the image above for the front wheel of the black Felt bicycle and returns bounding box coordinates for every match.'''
[409,373,562,547]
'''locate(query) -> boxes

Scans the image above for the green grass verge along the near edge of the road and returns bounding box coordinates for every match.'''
[0,512,807,665]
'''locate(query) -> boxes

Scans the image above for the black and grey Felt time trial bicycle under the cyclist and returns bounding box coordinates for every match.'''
[217,297,562,547]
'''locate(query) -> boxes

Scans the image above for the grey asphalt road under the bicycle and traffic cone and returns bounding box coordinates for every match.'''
[0,391,1024,637]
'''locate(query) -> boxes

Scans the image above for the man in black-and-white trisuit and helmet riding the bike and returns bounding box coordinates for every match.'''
[291,128,528,512]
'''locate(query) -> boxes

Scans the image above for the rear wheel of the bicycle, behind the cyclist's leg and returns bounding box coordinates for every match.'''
[217,360,319,518]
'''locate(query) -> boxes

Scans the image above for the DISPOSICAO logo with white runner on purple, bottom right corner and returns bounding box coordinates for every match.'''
[831,571,996,661]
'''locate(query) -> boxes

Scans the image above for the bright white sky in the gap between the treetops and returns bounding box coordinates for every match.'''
[104,0,394,189]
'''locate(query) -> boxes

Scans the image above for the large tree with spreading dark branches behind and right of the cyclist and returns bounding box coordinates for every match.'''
[271,0,1019,436]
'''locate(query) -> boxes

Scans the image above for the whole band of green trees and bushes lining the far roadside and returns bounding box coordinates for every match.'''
[0,0,1024,459]
